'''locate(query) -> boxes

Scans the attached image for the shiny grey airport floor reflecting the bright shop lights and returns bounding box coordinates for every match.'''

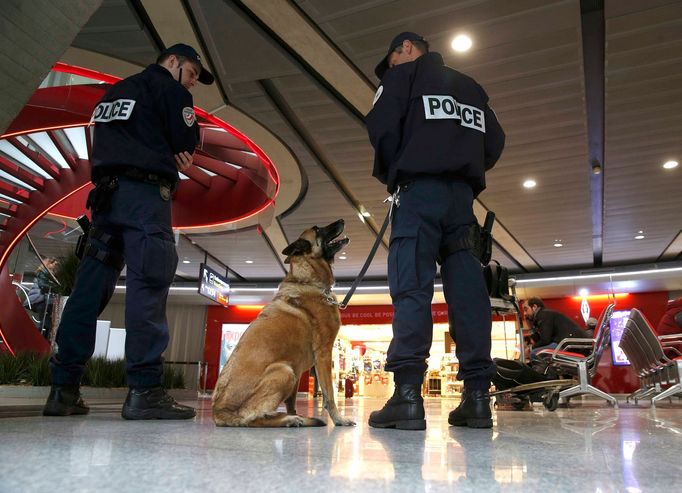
[0,398,682,493]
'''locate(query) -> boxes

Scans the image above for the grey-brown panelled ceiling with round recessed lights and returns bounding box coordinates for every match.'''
[10,0,682,302]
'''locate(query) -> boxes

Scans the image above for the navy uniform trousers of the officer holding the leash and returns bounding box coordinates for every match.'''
[385,177,495,390]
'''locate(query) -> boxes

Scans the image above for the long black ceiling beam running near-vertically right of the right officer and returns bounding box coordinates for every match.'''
[580,0,606,267]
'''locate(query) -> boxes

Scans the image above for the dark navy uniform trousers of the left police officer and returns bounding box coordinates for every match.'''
[50,177,178,387]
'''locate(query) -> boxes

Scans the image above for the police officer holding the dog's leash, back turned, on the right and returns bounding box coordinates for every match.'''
[366,32,505,429]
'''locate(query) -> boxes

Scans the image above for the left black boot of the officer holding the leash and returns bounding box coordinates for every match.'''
[369,383,426,430]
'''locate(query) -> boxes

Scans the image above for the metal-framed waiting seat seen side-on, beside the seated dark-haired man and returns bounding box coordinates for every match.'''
[539,303,618,407]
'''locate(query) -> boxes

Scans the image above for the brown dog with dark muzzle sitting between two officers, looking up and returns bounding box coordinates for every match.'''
[213,219,355,427]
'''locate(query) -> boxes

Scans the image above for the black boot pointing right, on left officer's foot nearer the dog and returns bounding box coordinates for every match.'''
[121,387,196,419]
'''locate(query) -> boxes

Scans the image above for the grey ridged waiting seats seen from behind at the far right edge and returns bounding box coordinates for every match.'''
[620,308,682,406]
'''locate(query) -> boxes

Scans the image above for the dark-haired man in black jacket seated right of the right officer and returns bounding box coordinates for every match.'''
[523,298,591,358]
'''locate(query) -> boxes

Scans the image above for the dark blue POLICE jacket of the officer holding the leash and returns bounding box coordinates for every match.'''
[365,52,505,197]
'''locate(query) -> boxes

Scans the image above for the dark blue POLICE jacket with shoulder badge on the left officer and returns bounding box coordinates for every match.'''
[92,64,198,182]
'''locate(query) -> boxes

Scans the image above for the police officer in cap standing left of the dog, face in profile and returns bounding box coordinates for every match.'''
[43,44,213,419]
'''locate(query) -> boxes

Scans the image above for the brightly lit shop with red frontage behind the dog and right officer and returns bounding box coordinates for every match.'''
[205,304,520,398]
